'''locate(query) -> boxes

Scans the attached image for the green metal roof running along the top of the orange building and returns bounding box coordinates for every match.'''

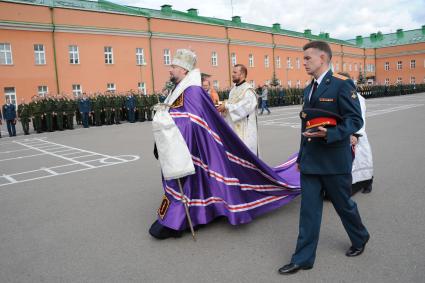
[0,0,425,48]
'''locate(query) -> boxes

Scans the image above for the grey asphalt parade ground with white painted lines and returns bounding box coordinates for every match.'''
[0,93,425,283]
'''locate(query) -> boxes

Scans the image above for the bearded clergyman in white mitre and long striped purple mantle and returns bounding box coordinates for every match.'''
[149,49,300,239]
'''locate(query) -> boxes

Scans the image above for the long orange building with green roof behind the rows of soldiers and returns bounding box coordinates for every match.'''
[0,0,425,105]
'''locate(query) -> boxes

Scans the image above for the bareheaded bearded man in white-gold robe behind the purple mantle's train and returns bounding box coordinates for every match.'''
[217,64,259,156]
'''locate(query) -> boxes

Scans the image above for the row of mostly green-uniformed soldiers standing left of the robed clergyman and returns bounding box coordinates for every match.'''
[12,91,160,135]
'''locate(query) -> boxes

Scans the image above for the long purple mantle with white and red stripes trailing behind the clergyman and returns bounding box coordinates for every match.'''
[158,86,300,230]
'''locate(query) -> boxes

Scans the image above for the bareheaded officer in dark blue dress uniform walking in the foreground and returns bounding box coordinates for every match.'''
[279,41,369,274]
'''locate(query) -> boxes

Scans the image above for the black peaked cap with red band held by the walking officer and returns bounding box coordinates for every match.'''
[300,108,342,131]
